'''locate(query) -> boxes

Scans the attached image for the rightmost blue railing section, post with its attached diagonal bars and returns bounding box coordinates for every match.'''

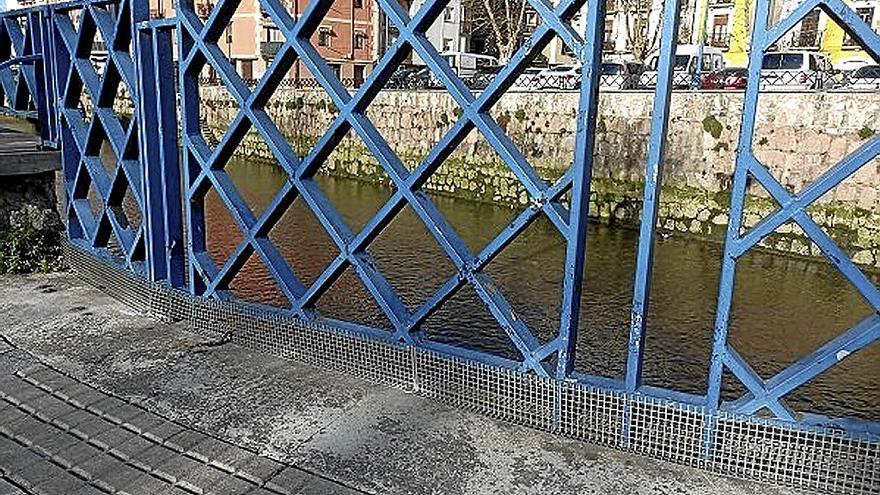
[707,0,880,421]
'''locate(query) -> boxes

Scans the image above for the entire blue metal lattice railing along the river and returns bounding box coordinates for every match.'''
[0,0,880,455]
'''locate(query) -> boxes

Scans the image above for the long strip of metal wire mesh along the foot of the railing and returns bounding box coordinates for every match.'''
[66,244,880,495]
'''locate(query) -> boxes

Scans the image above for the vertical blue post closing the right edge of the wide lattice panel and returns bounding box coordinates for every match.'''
[556,1,605,380]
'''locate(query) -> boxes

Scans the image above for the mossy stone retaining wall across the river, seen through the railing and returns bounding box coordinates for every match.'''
[201,88,880,266]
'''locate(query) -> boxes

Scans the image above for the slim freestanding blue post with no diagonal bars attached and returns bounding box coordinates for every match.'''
[626,0,681,393]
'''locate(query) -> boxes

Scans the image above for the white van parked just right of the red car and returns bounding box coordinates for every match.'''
[761,51,834,91]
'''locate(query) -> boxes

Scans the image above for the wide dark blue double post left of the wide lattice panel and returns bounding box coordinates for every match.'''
[136,17,185,287]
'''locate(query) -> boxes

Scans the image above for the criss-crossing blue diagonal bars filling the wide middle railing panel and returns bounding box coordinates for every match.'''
[175,2,600,373]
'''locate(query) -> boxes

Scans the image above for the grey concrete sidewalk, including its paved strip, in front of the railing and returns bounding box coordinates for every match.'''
[0,274,820,495]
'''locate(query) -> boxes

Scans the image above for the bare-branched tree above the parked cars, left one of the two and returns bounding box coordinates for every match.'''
[462,0,533,63]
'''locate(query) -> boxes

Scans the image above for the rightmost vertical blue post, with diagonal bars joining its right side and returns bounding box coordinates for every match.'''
[704,0,770,440]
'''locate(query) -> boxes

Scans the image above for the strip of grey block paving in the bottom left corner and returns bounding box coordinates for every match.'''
[0,350,364,495]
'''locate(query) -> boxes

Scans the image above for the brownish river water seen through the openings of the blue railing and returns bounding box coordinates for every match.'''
[206,160,880,420]
